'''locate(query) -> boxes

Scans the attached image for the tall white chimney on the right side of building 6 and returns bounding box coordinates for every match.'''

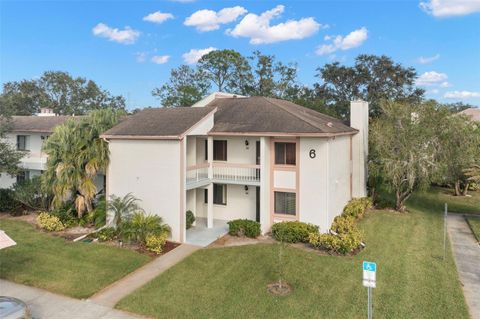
[350,100,369,197]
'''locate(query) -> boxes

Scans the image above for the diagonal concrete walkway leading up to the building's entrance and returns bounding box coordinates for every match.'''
[89,244,201,308]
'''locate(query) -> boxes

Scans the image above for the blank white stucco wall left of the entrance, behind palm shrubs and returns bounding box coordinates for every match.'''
[107,140,184,241]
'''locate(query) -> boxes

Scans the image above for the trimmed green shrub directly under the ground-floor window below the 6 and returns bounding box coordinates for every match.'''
[272,221,318,243]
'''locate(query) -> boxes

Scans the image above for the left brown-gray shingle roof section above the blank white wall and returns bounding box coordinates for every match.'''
[102,107,213,138]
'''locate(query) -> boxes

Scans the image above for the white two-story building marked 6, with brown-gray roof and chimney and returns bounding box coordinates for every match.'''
[102,93,368,242]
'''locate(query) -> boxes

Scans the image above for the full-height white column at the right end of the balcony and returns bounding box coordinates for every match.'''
[260,137,271,234]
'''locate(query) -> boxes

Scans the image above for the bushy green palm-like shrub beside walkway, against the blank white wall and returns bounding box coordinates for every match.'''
[120,211,170,245]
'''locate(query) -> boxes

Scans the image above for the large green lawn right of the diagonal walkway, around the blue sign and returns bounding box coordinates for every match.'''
[117,189,479,318]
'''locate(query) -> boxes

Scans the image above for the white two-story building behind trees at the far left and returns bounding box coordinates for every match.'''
[0,114,70,188]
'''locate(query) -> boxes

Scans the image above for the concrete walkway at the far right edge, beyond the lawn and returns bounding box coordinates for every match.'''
[447,214,480,319]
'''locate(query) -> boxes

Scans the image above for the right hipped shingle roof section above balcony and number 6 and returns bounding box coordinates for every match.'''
[208,97,357,135]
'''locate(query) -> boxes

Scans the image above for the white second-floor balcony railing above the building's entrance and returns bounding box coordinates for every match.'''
[186,162,260,189]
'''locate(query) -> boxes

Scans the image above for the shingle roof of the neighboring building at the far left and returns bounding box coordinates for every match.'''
[9,116,81,133]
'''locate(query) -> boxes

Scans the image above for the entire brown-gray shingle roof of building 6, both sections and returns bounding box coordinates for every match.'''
[102,97,357,139]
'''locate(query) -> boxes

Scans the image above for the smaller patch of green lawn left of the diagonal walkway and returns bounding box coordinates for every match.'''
[0,219,150,298]
